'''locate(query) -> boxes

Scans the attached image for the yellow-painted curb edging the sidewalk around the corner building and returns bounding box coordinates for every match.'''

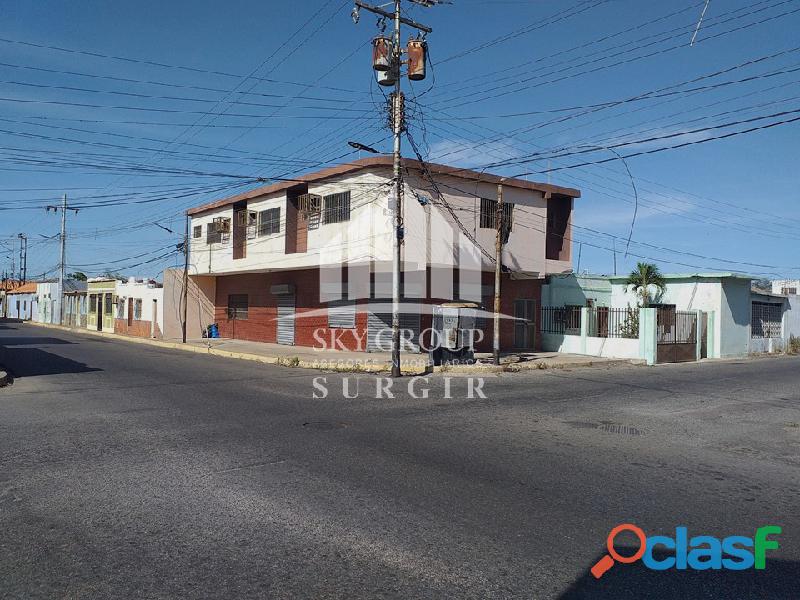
[21,321,634,375]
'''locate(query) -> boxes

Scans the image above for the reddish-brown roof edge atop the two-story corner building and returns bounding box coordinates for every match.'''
[186,155,581,215]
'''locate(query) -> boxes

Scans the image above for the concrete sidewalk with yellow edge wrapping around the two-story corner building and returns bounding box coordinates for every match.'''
[21,322,632,375]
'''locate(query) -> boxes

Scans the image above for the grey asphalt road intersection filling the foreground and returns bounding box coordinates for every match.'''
[0,323,800,600]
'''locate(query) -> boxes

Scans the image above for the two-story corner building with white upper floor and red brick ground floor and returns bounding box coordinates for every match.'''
[188,156,580,351]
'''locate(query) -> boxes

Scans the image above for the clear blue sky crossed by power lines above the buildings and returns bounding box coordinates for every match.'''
[0,0,800,279]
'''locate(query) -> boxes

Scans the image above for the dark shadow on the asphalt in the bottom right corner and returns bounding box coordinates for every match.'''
[558,547,800,600]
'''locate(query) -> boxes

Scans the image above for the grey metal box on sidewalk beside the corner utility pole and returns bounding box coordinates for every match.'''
[431,302,478,366]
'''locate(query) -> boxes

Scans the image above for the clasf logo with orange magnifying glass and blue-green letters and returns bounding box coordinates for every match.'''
[590,523,781,579]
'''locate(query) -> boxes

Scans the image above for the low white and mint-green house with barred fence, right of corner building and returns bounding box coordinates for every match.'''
[542,273,800,362]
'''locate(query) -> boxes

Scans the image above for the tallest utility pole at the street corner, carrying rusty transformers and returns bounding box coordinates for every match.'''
[352,0,438,377]
